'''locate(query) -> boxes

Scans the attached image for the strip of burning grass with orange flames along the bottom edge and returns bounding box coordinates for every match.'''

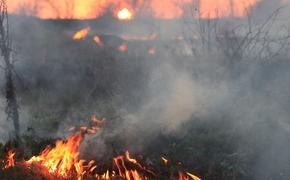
[0,116,200,180]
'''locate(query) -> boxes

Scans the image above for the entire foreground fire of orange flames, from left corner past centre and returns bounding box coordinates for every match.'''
[0,116,200,180]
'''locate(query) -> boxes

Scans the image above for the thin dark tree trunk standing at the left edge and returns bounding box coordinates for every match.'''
[0,0,20,141]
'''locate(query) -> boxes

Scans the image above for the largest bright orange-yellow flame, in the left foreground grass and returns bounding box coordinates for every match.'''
[26,115,105,178]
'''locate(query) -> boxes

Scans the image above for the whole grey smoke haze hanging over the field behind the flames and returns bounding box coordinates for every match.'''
[0,1,290,179]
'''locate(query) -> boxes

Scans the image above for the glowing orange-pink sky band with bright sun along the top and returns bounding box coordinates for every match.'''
[7,0,259,19]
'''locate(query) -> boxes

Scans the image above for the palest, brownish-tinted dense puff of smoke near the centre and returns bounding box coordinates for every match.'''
[120,59,226,137]
